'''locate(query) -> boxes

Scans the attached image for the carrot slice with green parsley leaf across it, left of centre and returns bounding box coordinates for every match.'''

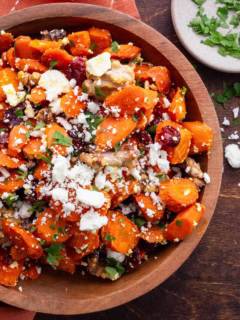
[45,123,70,156]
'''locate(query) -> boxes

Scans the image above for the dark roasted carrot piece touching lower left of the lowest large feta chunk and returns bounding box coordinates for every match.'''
[67,225,99,260]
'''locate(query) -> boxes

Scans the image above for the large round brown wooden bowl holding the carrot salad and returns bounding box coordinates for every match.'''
[0,3,222,314]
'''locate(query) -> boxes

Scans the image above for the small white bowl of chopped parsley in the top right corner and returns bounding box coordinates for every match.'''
[171,0,240,73]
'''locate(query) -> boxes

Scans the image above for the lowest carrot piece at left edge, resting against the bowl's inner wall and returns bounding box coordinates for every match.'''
[0,260,24,287]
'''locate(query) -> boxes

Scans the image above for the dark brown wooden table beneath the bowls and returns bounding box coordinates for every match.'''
[35,0,240,320]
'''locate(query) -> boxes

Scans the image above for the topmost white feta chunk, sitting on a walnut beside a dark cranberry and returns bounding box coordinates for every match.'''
[86,52,112,77]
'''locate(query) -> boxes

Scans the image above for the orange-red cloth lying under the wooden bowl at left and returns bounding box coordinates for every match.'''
[0,0,140,320]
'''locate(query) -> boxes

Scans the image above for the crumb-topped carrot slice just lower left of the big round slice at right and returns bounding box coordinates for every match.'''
[133,193,164,222]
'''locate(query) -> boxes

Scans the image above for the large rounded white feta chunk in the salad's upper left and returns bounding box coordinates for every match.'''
[38,70,70,102]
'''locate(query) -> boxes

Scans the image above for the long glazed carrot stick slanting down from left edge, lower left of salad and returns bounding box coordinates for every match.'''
[2,218,43,259]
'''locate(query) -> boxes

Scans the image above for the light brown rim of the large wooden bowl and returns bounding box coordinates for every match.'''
[0,3,223,314]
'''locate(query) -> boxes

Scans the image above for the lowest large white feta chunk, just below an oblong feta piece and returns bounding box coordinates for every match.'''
[80,208,108,231]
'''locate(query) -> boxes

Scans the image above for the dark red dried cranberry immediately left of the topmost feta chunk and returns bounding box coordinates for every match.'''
[64,58,86,86]
